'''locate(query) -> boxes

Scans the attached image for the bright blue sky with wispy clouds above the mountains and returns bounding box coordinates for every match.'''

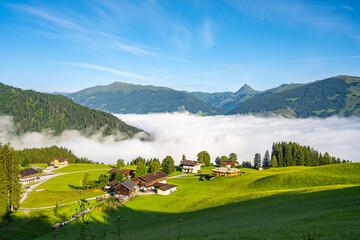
[0,0,360,92]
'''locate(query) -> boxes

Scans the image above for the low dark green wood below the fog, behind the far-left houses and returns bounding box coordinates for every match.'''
[16,145,95,166]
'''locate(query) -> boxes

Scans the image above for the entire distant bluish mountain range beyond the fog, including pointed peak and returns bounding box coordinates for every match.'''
[62,75,360,118]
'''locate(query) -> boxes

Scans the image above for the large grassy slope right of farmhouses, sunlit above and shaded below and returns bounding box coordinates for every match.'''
[17,163,360,239]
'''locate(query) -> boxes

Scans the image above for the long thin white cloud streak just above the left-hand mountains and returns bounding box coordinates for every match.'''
[55,62,152,80]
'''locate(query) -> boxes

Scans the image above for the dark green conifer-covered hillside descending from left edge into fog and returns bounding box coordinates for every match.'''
[0,83,141,139]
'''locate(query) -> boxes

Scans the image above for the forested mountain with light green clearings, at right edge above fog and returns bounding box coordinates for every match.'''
[230,76,360,118]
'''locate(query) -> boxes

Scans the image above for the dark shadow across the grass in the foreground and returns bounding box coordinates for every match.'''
[12,187,360,240]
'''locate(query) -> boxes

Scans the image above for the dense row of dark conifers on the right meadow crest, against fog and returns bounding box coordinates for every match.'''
[254,142,349,168]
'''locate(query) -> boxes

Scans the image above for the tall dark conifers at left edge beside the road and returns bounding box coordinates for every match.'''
[0,143,21,219]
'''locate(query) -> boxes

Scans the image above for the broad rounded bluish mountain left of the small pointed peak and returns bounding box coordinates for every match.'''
[67,82,221,115]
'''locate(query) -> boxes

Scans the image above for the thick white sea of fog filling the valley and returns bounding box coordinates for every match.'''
[0,112,360,163]
